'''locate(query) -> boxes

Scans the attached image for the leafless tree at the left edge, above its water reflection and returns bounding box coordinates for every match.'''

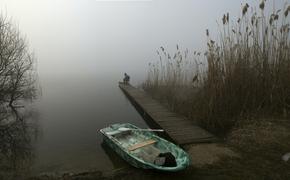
[0,15,37,122]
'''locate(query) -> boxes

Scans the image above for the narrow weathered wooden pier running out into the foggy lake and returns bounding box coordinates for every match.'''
[119,83,216,145]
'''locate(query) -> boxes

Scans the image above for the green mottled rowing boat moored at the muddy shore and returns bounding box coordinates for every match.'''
[100,123,189,171]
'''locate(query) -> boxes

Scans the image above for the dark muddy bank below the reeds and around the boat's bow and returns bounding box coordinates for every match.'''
[28,119,290,180]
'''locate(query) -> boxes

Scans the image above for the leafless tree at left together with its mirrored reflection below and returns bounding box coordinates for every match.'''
[0,14,38,179]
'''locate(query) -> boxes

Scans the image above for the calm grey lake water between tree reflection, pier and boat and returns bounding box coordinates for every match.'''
[33,77,147,174]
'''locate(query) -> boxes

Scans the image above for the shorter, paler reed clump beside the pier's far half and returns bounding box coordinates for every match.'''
[143,45,201,113]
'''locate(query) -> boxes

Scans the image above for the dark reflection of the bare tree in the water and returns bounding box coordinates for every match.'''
[0,107,38,179]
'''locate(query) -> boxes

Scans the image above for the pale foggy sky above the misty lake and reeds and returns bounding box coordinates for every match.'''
[0,0,289,83]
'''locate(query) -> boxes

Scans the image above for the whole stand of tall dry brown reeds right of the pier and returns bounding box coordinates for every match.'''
[144,1,290,132]
